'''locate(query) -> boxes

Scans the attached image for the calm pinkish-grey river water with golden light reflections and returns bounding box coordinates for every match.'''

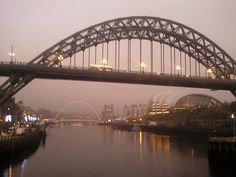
[0,125,214,177]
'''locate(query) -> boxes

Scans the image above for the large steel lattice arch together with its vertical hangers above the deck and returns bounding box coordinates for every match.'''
[0,16,236,103]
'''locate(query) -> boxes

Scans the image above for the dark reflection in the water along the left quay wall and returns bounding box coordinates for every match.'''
[0,136,46,177]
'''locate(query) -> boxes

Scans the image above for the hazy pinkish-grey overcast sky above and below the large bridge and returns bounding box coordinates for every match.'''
[0,0,236,112]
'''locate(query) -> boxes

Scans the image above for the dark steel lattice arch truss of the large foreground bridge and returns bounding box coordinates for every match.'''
[0,16,236,103]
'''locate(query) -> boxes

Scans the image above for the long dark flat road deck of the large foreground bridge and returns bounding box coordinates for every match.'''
[0,62,236,91]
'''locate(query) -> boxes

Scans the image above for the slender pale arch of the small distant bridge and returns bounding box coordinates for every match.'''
[53,100,101,122]
